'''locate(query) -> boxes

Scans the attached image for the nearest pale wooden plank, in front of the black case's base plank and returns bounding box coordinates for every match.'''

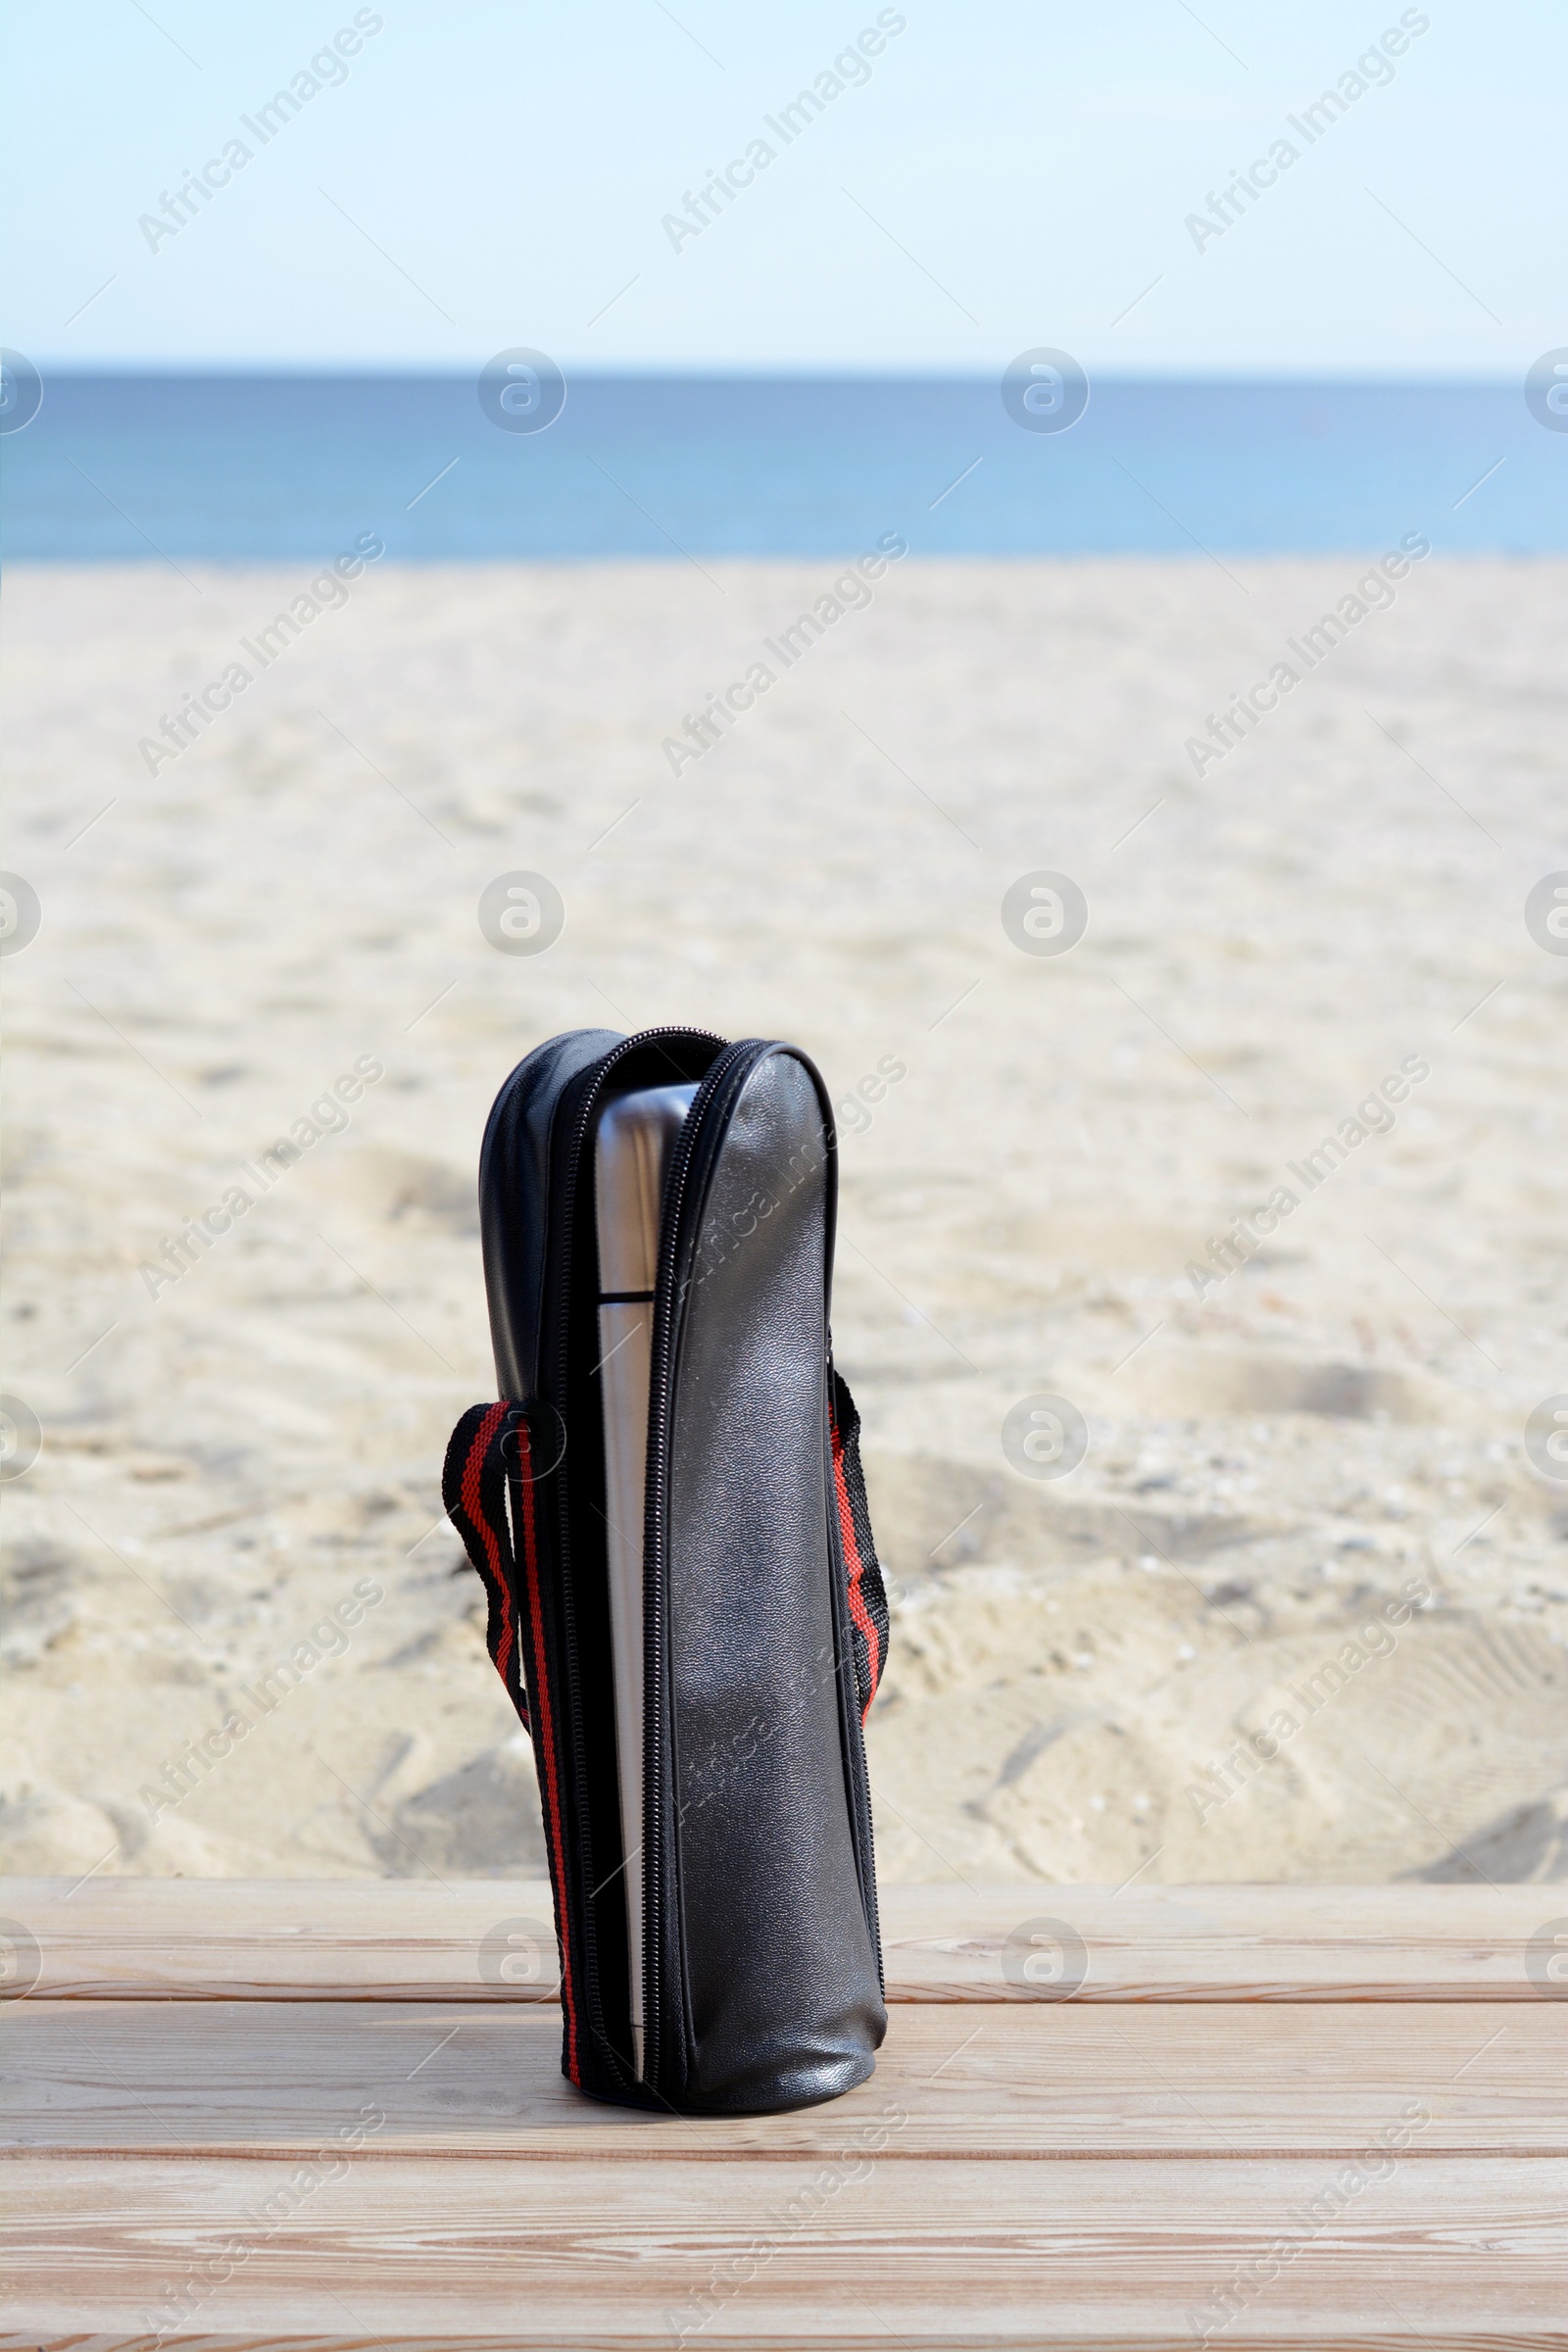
[0,2133,1568,2352]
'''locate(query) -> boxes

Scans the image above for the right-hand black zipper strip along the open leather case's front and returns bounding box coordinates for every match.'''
[642,1037,771,2095]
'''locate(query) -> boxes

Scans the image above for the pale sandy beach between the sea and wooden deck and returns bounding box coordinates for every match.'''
[0,551,1568,1884]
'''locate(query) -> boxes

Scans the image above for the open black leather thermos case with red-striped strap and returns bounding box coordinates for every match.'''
[444,1030,889,2115]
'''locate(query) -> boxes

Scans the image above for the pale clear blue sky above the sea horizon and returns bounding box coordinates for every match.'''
[0,0,1568,381]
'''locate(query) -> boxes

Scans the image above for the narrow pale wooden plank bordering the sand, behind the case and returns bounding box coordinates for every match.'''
[0,1880,1568,2001]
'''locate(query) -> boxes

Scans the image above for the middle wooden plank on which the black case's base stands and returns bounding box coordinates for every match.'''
[0,2001,1568,2164]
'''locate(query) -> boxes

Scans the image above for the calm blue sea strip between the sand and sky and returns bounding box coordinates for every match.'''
[0,374,1568,563]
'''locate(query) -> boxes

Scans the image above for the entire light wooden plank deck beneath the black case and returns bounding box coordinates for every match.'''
[0,1880,1568,2352]
